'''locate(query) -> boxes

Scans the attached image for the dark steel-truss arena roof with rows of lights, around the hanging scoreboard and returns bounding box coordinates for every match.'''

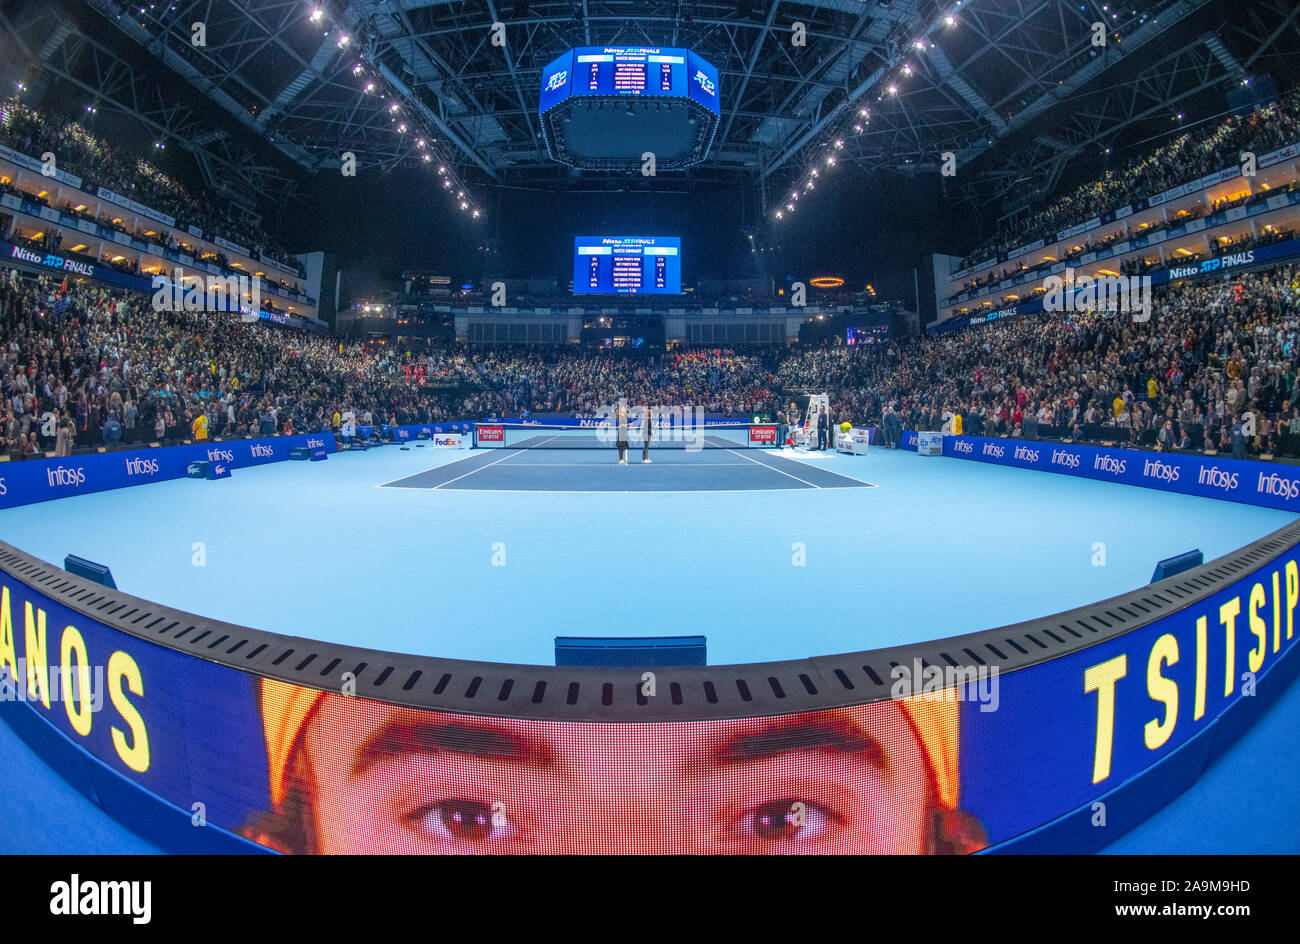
[0,0,1300,230]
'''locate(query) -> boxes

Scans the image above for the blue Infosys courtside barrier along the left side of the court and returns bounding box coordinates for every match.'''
[0,433,335,508]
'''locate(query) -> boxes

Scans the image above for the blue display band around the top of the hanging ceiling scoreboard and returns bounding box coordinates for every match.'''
[538,46,719,113]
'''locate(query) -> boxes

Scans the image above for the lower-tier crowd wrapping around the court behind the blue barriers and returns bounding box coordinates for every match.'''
[0,254,1300,465]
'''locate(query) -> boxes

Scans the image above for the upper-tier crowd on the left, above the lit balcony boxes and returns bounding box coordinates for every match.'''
[0,101,306,283]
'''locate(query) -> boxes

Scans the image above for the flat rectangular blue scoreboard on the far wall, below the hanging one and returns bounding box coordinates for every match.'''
[573,237,681,295]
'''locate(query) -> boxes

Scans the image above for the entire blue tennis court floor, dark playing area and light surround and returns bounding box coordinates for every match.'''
[0,446,1292,664]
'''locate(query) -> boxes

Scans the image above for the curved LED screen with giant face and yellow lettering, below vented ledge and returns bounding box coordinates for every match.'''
[0,525,1300,853]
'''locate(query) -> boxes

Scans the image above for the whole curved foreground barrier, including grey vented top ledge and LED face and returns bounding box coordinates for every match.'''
[0,509,1300,852]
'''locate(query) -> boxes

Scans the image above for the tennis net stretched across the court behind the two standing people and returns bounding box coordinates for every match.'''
[475,423,776,450]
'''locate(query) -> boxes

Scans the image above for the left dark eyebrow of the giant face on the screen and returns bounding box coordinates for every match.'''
[351,722,555,779]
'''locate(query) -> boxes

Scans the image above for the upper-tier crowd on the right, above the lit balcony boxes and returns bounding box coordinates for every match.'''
[961,87,1300,268]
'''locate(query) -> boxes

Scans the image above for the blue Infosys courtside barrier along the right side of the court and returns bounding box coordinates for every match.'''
[944,436,1300,512]
